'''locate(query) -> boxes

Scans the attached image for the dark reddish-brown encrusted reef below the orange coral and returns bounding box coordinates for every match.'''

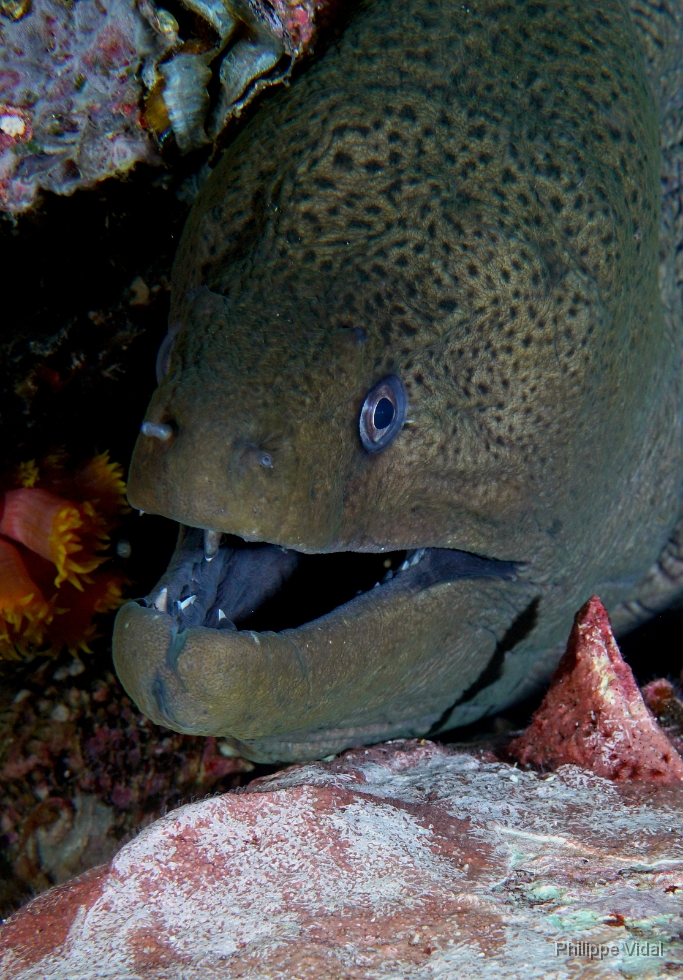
[0,649,254,914]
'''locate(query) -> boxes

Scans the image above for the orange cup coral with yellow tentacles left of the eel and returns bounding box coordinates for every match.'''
[0,452,128,659]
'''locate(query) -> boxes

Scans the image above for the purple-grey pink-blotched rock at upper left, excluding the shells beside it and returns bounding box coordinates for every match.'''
[0,0,158,212]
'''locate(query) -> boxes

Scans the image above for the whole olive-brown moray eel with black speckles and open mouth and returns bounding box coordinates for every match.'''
[114,0,683,760]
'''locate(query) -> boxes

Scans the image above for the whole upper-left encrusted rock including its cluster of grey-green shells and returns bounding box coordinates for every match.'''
[0,0,330,214]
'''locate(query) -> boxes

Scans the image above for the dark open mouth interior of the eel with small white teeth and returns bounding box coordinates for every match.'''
[140,525,517,632]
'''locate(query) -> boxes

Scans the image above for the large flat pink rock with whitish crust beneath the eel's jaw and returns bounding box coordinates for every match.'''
[0,742,683,980]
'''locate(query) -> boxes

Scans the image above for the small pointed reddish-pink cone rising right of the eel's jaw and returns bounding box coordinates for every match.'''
[508,596,683,783]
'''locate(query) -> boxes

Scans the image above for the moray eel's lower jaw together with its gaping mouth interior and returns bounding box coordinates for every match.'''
[114,528,530,761]
